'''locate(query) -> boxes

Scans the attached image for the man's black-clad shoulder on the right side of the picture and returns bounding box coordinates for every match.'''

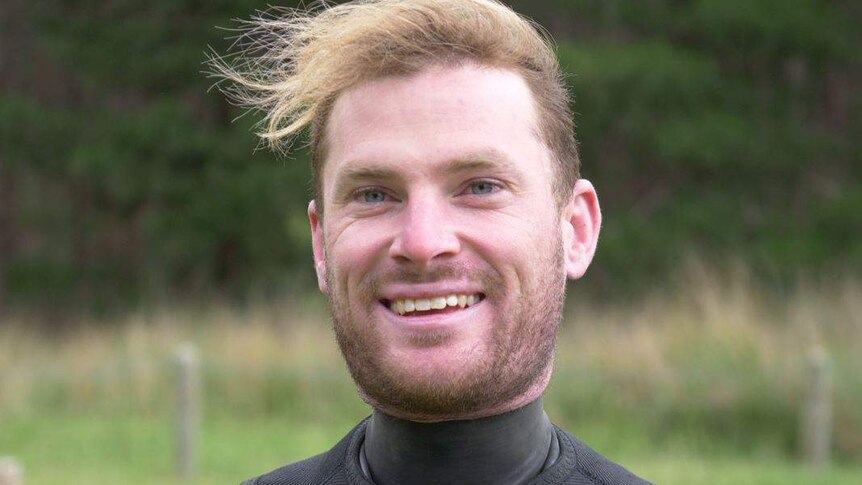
[549,427,650,485]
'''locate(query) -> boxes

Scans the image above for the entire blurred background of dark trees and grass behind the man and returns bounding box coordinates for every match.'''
[0,0,862,484]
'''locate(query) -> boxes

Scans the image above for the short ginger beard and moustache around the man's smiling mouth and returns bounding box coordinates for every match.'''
[326,232,566,421]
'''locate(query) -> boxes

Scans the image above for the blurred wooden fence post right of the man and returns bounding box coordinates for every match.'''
[800,346,832,468]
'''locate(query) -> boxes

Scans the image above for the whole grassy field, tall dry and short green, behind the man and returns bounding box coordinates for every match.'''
[0,266,862,485]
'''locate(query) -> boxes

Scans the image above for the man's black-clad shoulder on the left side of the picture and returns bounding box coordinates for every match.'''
[240,420,365,485]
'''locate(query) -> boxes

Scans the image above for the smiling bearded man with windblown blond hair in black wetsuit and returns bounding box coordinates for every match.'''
[214,0,646,485]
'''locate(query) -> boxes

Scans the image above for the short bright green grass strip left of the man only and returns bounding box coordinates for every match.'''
[0,415,364,484]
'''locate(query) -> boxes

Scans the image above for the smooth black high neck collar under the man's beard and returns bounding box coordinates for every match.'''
[363,398,555,485]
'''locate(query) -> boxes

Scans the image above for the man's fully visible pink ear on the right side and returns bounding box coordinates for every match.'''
[560,179,602,280]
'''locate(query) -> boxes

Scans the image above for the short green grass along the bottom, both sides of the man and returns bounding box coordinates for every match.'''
[0,415,862,485]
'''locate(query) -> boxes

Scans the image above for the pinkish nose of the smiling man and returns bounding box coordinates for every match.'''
[389,194,461,267]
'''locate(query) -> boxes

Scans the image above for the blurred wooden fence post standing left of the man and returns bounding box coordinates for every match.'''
[175,342,200,481]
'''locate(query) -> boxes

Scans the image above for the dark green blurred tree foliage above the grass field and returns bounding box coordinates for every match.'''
[0,0,862,307]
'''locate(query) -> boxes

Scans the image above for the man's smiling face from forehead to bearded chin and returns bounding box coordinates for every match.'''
[309,64,598,421]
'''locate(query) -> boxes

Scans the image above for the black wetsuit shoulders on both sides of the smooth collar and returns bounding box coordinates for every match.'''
[242,419,650,485]
